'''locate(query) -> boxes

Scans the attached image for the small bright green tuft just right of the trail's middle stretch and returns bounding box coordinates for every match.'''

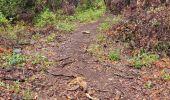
[108,50,120,61]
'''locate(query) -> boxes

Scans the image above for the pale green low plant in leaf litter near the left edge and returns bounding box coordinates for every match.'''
[4,53,26,65]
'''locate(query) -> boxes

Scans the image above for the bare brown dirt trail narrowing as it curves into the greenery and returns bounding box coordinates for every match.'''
[34,17,146,100]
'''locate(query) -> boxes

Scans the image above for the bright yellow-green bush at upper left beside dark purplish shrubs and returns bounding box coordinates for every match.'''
[34,9,56,27]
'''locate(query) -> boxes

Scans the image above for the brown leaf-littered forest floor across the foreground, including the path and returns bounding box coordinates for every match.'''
[0,13,170,100]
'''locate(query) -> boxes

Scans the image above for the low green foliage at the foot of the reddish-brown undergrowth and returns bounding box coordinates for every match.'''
[131,53,159,69]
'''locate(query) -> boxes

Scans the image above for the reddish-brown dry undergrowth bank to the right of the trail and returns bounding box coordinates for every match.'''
[107,6,170,55]
